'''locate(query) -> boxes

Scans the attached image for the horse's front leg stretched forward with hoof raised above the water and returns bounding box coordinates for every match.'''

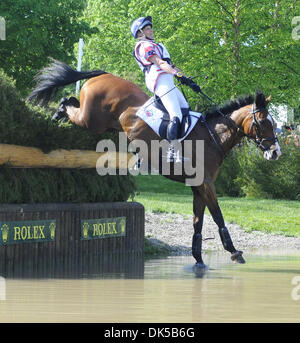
[204,184,245,263]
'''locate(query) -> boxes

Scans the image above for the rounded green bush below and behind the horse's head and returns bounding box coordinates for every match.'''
[216,140,300,200]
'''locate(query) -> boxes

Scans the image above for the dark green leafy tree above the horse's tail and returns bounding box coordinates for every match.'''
[0,0,95,94]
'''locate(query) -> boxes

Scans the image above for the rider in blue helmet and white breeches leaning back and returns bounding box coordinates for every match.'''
[130,16,197,160]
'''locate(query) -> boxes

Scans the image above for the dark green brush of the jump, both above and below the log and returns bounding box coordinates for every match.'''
[0,70,135,203]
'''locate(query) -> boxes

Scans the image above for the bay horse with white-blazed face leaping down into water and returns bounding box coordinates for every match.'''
[27,60,281,270]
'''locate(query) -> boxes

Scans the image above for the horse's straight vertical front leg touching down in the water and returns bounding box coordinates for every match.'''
[192,187,207,270]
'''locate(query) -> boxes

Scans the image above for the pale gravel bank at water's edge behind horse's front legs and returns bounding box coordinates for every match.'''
[145,212,300,255]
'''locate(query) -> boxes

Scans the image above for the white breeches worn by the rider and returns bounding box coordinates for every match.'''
[155,74,189,121]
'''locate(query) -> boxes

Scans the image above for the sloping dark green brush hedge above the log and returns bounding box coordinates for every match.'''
[0,69,101,152]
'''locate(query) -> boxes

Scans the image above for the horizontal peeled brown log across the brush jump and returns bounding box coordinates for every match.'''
[0,144,136,169]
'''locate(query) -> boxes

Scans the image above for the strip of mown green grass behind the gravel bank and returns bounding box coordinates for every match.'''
[134,175,300,237]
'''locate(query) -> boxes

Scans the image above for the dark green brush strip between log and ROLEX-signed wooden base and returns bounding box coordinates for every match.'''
[0,167,135,204]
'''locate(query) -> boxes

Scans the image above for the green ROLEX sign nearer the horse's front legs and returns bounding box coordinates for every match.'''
[81,217,126,240]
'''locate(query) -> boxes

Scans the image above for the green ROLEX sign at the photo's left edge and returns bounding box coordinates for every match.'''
[0,220,56,245]
